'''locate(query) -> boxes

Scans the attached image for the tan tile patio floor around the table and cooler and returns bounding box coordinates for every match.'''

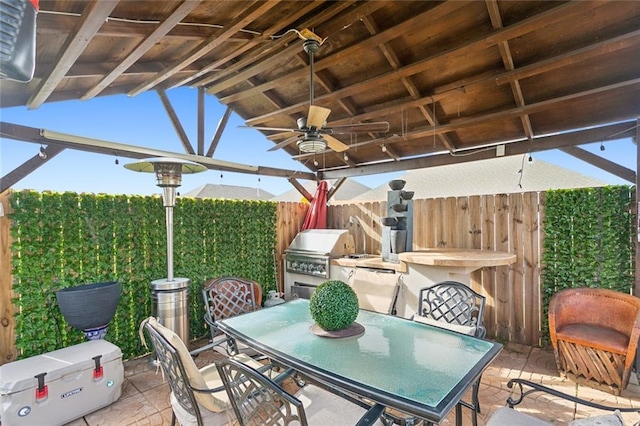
[68,344,640,426]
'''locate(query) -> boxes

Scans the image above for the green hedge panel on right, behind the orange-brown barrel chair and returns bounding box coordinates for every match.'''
[542,186,635,342]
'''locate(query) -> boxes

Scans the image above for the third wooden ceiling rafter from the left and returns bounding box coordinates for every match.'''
[128,0,280,96]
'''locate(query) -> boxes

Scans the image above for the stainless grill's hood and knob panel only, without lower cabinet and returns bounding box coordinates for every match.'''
[285,229,354,279]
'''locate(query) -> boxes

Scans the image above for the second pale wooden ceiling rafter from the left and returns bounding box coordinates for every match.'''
[80,0,200,101]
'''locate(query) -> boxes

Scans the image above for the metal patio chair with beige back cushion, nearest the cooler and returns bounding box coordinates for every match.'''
[140,317,271,426]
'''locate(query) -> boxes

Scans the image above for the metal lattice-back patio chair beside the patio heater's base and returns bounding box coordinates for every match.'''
[191,277,262,356]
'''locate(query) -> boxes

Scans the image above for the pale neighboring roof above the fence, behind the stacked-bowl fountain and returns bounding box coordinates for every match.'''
[352,155,607,201]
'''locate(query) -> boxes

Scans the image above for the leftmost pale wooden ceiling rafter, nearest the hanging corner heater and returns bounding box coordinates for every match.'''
[27,1,118,109]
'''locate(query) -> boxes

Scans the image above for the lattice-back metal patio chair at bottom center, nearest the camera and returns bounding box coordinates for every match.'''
[216,359,384,426]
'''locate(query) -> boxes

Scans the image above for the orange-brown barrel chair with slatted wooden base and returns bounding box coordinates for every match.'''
[549,288,640,395]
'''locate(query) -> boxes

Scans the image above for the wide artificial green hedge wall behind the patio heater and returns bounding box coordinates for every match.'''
[10,191,277,359]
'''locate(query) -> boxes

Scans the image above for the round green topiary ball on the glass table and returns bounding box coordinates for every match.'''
[309,280,358,331]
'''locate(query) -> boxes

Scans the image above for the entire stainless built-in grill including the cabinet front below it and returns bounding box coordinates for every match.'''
[284,229,354,298]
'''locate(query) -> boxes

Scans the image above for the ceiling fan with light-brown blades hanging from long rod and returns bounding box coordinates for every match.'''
[241,29,389,152]
